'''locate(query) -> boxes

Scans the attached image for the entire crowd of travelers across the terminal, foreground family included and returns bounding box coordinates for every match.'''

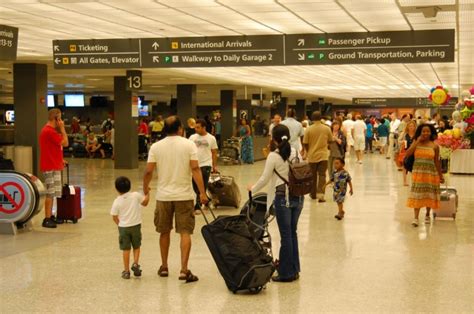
[40,109,453,282]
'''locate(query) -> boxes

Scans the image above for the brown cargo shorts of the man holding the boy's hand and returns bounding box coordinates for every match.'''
[155,200,196,234]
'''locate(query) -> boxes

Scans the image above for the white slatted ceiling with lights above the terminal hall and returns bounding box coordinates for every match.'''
[0,0,474,104]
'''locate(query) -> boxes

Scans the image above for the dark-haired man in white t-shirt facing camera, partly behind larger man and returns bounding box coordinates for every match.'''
[189,119,218,213]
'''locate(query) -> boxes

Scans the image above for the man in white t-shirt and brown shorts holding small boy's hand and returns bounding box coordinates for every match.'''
[143,116,208,282]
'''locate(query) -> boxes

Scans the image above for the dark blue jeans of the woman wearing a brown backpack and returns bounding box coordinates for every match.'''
[274,193,304,279]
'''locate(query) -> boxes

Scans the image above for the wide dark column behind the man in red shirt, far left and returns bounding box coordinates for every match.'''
[13,63,48,175]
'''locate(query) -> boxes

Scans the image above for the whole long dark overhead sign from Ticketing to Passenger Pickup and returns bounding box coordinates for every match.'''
[53,30,454,69]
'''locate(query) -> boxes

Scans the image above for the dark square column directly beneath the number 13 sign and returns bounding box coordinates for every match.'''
[114,76,138,169]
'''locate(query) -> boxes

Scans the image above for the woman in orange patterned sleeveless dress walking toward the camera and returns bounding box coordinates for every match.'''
[406,124,444,227]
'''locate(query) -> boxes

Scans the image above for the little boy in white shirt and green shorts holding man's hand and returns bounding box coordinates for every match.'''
[110,177,150,279]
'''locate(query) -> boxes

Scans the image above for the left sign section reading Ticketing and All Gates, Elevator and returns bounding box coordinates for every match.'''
[53,39,141,69]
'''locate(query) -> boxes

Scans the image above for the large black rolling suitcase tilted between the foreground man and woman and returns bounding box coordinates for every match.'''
[201,204,275,293]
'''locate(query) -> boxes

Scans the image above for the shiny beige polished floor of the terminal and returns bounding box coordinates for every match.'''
[0,155,474,313]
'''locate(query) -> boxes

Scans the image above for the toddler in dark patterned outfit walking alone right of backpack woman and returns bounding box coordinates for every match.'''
[325,158,354,220]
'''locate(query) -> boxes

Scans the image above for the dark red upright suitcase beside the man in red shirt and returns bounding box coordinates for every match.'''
[57,165,82,223]
